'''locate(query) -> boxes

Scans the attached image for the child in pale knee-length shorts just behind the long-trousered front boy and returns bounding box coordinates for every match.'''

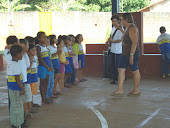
[19,39,37,118]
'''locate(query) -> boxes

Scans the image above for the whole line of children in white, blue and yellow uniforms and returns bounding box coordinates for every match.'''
[4,32,85,128]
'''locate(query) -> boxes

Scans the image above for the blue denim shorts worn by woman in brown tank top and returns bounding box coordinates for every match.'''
[118,52,139,71]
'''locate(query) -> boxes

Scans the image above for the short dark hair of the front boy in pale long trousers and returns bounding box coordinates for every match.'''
[10,45,23,57]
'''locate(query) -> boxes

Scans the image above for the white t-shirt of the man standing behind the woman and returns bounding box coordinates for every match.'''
[110,27,123,54]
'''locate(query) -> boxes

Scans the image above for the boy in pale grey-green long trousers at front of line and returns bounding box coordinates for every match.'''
[7,45,27,128]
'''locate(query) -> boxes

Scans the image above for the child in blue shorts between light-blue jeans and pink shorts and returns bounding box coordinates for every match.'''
[49,35,62,95]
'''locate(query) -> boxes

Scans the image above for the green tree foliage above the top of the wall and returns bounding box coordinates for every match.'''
[0,0,151,12]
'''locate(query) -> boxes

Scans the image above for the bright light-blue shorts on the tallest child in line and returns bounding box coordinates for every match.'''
[38,65,51,79]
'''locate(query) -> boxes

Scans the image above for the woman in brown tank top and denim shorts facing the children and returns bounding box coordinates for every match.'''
[112,13,140,96]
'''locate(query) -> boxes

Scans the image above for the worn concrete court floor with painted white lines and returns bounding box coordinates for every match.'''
[0,72,170,128]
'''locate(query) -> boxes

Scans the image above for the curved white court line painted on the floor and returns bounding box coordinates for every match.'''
[88,106,108,128]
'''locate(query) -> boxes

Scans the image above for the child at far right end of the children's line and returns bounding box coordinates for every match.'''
[76,34,87,82]
